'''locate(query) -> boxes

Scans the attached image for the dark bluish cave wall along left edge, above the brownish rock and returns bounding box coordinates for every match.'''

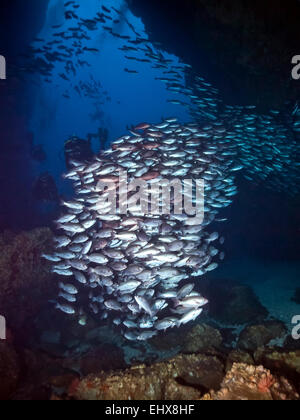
[0,0,48,230]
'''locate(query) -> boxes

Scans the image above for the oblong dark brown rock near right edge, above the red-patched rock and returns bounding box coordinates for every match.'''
[238,321,287,352]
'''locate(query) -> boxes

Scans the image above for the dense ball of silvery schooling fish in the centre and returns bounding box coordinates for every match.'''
[44,119,242,341]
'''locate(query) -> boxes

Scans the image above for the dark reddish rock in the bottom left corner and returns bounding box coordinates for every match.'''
[0,341,20,400]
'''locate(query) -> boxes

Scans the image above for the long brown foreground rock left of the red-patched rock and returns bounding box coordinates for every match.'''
[70,355,224,400]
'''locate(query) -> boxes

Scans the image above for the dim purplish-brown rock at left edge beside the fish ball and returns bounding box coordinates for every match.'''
[0,228,56,339]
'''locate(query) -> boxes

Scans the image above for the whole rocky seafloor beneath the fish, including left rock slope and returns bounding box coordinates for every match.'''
[0,228,300,400]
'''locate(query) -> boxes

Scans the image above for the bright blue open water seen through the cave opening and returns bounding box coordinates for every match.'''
[28,0,190,195]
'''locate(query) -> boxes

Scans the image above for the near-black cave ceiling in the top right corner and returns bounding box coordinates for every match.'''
[129,0,300,110]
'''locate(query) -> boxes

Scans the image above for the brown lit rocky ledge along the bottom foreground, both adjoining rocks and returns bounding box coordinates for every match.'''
[55,355,299,401]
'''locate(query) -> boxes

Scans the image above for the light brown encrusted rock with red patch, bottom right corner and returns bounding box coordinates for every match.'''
[203,363,299,401]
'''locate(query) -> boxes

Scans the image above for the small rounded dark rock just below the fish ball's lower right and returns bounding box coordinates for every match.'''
[183,324,223,353]
